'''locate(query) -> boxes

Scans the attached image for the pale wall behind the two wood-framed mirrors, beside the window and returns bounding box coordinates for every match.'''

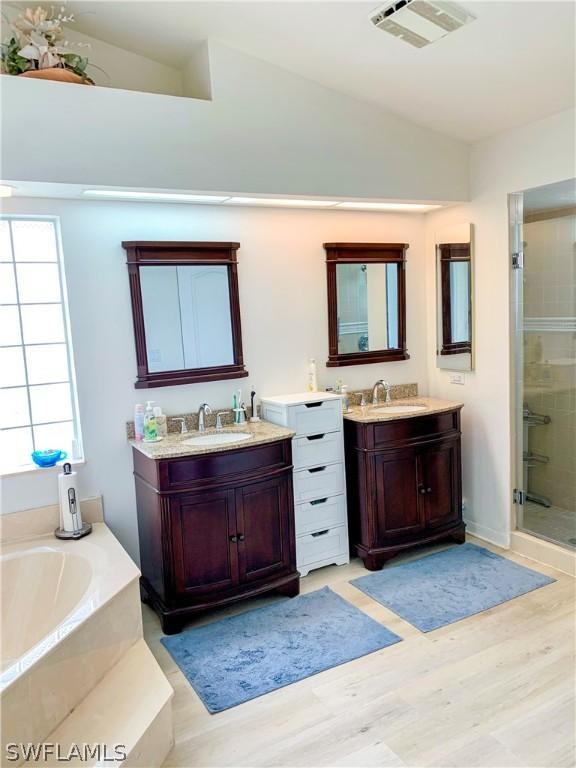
[2,198,426,558]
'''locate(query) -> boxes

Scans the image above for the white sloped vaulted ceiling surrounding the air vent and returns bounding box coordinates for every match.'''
[35,0,576,141]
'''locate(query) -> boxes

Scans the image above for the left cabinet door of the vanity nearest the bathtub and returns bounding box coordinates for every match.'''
[170,491,239,597]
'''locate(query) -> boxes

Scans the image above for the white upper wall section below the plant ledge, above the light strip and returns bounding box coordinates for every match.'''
[0,43,468,200]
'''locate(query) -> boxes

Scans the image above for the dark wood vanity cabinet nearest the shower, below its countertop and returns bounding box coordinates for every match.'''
[344,406,465,571]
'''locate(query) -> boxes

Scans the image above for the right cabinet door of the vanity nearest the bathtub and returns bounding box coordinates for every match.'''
[236,475,295,582]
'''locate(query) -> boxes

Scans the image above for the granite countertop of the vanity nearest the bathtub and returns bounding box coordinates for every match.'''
[130,421,295,460]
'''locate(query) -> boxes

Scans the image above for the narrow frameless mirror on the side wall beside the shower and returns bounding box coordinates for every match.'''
[436,224,474,371]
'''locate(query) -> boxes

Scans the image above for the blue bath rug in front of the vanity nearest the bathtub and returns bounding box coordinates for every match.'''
[162,587,402,712]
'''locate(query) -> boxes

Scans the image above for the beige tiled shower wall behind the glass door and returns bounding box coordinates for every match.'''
[524,216,576,511]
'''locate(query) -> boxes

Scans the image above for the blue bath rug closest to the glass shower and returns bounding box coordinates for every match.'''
[351,544,556,632]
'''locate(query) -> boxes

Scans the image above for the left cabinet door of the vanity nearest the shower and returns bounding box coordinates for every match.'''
[370,448,424,546]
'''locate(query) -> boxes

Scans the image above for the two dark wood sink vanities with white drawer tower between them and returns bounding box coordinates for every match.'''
[132,392,464,634]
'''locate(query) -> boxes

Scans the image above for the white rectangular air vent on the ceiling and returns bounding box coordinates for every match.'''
[370,0,476,48]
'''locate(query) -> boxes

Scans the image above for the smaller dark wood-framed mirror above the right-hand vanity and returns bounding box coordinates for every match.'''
[324,243,410,367]
